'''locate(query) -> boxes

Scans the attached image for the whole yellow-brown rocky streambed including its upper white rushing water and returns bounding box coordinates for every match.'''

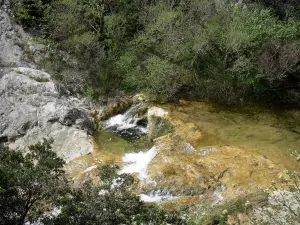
[67,101,300,209]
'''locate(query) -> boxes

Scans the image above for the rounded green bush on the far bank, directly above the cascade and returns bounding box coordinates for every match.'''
[117,5,197,100]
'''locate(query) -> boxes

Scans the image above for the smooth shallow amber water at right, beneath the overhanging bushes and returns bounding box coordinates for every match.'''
[161,101,300,171]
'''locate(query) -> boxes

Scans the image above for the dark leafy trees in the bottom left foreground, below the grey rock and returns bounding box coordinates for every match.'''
[0,140,186,225]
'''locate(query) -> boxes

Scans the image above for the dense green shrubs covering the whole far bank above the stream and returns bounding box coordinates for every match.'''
[8,0,300,105]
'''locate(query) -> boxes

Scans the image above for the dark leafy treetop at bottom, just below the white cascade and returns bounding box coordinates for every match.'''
[47,165,186,225]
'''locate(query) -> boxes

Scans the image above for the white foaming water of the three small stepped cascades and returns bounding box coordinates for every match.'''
[103,104,171,202]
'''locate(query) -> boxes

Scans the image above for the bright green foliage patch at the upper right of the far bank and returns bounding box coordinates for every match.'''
[224,8,299,51]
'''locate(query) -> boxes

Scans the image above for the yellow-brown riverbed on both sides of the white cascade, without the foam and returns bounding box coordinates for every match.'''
[66,101,300,200]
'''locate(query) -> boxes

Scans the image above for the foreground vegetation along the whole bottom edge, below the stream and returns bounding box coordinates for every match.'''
[0,140,300,225]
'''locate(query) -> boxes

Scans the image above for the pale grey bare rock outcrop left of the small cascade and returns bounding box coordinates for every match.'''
[0,67,92,161]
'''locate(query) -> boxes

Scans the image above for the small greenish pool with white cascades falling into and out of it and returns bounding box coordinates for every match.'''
[67,105,156,183]
